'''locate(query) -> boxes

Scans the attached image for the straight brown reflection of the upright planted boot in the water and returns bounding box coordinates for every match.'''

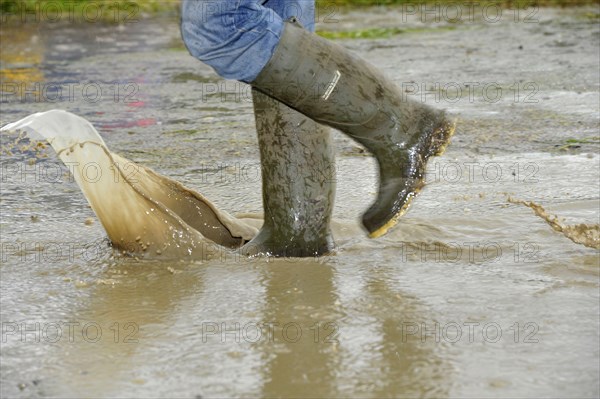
[261,259,343,398]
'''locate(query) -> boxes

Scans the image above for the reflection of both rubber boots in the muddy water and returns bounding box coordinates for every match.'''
[262,259,450,397]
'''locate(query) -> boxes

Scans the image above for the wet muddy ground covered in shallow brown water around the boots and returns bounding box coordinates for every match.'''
[0,8,600,398]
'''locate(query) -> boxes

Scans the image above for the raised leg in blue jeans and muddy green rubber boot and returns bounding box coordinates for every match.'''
[182,0,454,241]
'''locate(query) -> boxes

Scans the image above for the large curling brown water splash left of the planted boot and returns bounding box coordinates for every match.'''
[0,110,257,257]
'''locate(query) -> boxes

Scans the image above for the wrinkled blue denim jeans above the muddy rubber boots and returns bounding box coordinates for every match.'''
[181,0,315,83]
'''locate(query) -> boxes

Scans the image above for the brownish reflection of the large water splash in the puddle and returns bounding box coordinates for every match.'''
[46,258,203,397]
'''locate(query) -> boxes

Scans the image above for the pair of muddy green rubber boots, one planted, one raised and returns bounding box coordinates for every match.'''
[242,19,454,257]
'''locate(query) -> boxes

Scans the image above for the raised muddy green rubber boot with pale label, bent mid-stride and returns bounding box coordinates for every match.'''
[252,20,454,238]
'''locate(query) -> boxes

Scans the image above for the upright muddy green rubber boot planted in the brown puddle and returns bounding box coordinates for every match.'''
[241,90,335,257]
